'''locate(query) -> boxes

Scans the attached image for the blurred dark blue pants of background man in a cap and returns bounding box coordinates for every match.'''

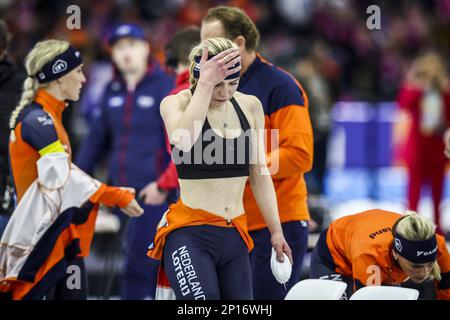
[120,203,167,300]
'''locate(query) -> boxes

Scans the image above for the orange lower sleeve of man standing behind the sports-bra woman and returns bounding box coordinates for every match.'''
[267,105,314,179]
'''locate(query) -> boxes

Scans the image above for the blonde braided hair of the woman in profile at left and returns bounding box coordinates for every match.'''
[9,40,69,130]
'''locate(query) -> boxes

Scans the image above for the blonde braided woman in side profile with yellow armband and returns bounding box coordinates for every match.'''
[0,40,142,299]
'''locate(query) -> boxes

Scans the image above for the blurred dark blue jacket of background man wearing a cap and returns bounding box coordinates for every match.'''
[75,62,174,190]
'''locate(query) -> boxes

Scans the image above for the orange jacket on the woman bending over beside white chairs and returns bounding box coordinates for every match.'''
[326,209,450,299]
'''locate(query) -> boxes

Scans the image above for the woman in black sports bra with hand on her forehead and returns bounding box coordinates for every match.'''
[148,38,292,299]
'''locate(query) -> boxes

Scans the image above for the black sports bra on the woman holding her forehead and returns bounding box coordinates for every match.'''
[171,97,251,179]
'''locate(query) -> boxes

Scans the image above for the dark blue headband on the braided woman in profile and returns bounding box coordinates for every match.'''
[34,46,83,83]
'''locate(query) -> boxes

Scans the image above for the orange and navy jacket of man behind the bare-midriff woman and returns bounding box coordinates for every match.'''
[238,54,313,231]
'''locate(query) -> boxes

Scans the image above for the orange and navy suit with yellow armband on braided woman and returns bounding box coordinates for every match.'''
[4,89,134,299]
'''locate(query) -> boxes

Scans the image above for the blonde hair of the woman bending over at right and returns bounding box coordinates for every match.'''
[393,211,441,281]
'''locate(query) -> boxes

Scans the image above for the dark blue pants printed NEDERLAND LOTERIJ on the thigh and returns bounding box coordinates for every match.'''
[163,225,253,300]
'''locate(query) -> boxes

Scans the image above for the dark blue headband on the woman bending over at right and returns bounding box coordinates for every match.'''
[394,233,437,263]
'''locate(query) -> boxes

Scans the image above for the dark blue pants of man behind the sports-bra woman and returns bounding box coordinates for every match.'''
[250,221,308,300]
